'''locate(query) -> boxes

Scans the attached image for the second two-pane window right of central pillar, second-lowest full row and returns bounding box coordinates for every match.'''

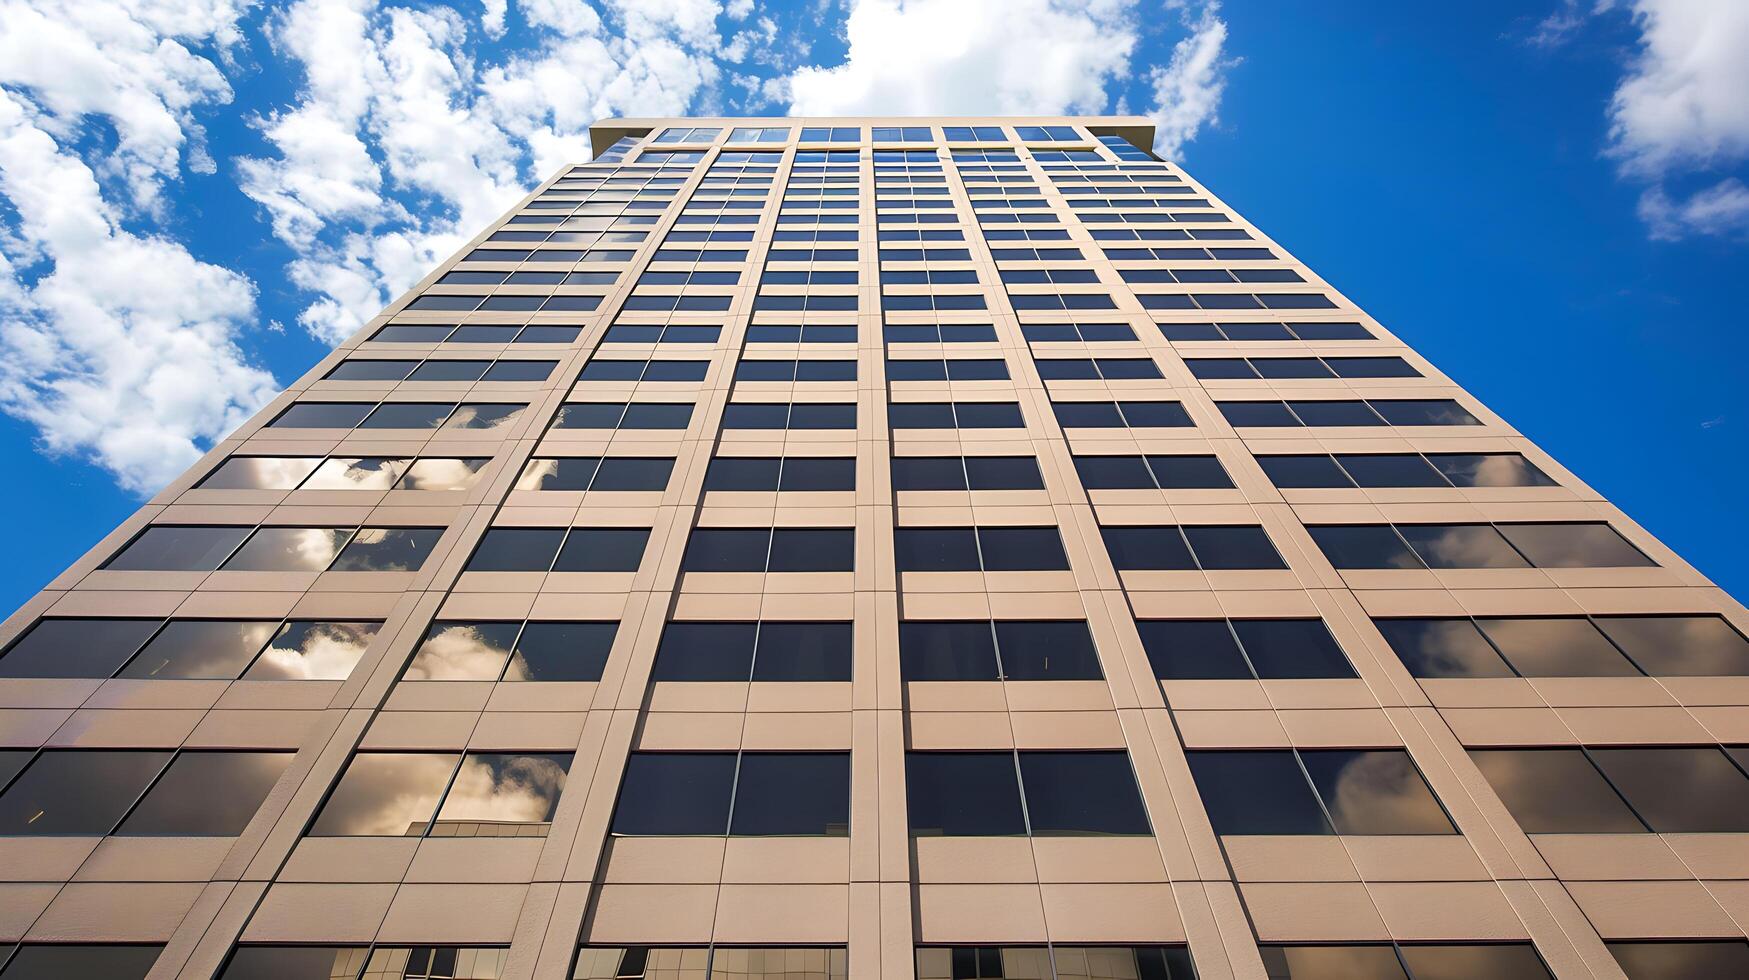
[1137,620,1355,681]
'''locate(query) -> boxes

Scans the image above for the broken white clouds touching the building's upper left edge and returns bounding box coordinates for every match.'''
[238,0,721,343]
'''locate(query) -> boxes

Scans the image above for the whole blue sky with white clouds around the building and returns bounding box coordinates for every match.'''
[0,0,1749,609]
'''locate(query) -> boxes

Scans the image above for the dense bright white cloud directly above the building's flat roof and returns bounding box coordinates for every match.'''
[789,0,1137,116]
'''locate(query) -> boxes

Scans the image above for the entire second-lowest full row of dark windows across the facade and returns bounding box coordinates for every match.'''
[10,609,1749,681]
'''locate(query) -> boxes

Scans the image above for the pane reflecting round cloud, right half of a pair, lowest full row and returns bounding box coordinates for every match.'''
[1300,749,1457,835]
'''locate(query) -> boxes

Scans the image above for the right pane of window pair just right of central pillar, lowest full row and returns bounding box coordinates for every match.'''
[1020,753,1149,837]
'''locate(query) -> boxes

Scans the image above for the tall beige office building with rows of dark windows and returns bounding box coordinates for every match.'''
[0,117,1749,980]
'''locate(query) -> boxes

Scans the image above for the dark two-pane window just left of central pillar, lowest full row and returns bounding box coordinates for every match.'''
[612,753,850,837]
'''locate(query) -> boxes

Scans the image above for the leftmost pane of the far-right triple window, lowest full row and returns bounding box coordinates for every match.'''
[1469,749,1646,833]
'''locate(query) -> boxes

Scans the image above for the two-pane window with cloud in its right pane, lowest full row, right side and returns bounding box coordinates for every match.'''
[1188,749,1457,835]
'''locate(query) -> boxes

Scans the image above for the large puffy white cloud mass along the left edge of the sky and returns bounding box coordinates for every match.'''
[0,0,276,492]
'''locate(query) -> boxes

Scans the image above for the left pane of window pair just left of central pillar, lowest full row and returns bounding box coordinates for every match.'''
[612,753,735,837]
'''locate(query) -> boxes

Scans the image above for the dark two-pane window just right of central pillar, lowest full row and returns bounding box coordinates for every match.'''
[904,751,1151,837]
